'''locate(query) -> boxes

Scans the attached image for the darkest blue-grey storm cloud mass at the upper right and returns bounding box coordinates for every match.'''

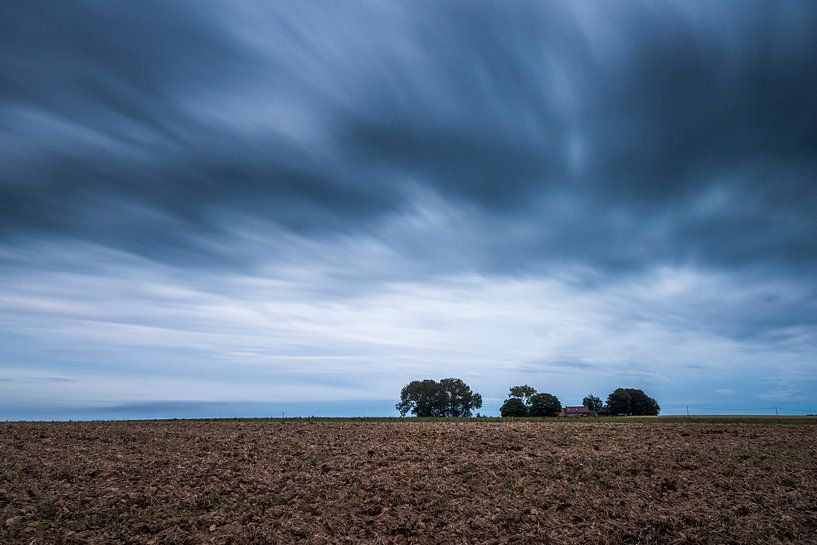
[576,3,817,266]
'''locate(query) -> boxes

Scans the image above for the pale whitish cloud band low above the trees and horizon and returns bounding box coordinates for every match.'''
[0,241,817,408]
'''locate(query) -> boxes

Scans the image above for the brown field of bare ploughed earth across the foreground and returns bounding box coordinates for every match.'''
[0,420,817,545]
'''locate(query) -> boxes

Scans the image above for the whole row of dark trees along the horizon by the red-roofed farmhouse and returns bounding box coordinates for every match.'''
[395,378,661,418]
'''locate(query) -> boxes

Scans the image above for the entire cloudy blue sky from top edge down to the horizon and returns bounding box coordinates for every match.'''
[0,0,817,420]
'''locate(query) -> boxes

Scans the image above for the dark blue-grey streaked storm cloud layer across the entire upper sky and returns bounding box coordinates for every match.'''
[0,2,817,274]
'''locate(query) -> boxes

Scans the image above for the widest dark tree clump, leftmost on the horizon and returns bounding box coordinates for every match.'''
[395,378,482,417]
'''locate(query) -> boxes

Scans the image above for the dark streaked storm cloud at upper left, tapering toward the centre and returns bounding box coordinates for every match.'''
[0,3,402,259]
